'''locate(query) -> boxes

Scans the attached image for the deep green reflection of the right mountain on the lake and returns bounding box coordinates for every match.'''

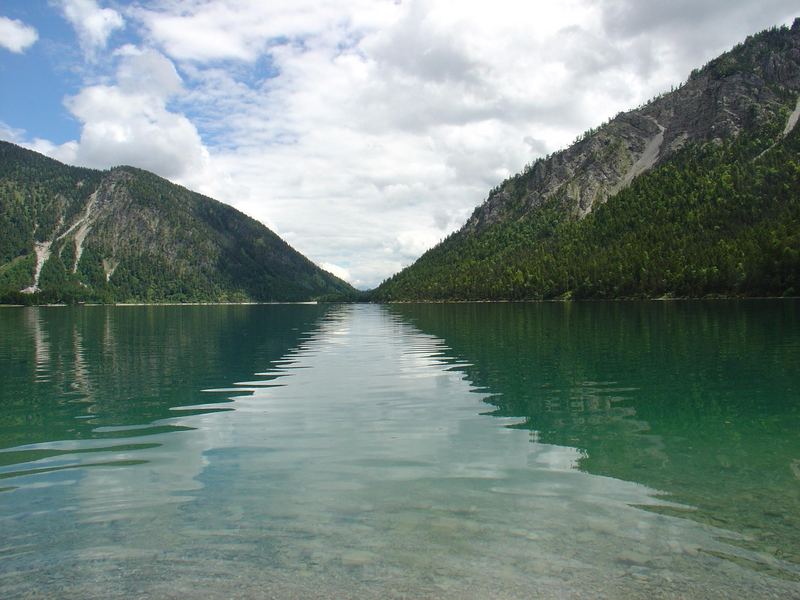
[394,301,800,568]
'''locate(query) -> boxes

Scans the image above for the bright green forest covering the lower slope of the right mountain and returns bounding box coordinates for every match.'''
[373,124,800,301]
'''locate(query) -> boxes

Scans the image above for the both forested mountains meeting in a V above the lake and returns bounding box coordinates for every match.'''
[0,19,800,304]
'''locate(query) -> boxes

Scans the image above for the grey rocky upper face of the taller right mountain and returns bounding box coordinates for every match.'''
[463,18,800,233]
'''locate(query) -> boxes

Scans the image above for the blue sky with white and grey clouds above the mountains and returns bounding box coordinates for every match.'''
[0,0,800,289]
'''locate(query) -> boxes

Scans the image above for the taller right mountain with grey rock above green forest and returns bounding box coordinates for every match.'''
[372,19,800,301]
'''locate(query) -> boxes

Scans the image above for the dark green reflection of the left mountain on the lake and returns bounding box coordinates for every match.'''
[0,305,328,450]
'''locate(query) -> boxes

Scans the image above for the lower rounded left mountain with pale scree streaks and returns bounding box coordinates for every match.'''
[0,142,355,304]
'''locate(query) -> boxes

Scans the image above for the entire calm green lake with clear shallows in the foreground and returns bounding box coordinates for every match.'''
[0,301,800,599]
